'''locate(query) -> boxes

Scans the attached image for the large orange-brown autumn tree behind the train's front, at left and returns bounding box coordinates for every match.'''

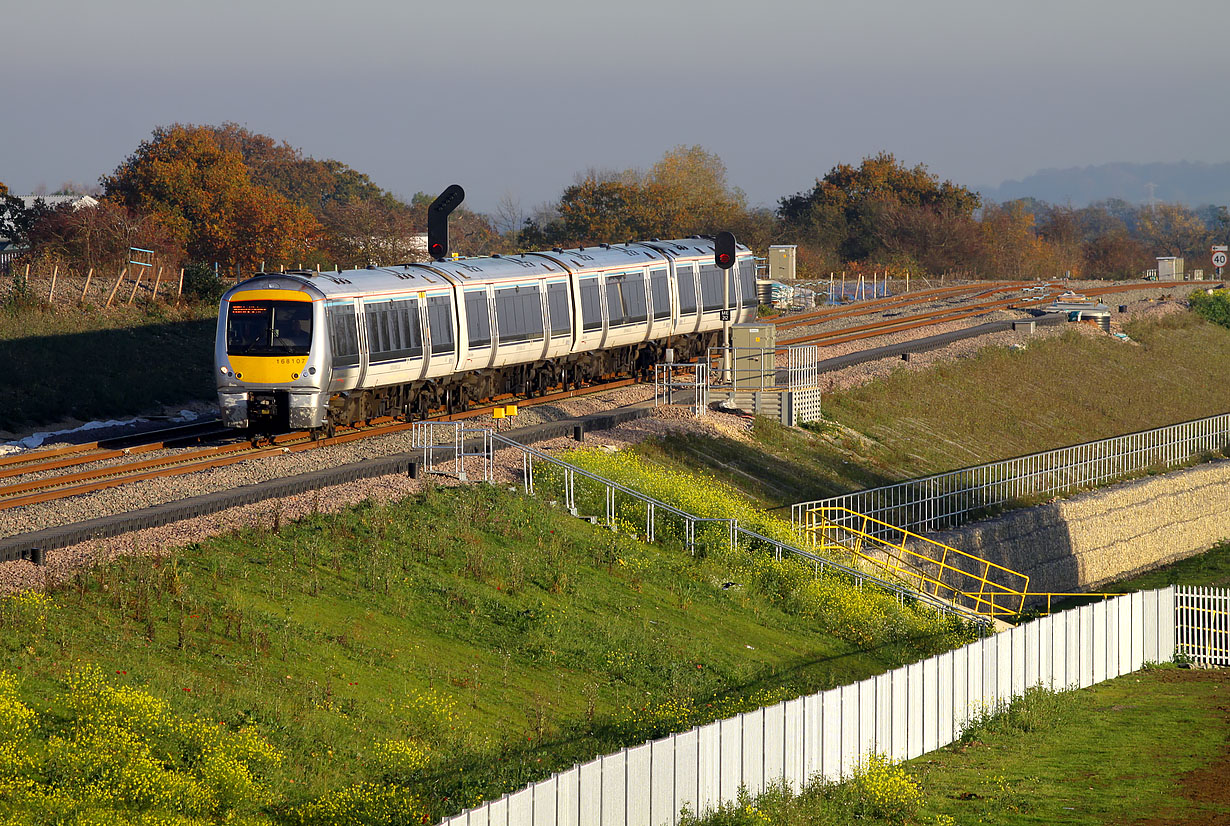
[101,124,323,269]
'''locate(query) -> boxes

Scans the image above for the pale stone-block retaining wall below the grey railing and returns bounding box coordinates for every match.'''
[930,461,1230,592]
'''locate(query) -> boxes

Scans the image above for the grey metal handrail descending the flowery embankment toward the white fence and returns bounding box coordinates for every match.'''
[462,423,989,629]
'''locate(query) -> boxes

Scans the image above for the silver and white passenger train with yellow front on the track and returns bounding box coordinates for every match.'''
[214,236,758,433]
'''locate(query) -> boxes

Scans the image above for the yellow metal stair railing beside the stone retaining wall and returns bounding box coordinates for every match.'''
[804,499,1030,617]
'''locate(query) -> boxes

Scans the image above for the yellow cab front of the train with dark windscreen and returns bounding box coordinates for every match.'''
[214,275,327,433]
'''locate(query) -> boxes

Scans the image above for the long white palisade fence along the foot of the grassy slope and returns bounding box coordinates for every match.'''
[444,588,1190,826]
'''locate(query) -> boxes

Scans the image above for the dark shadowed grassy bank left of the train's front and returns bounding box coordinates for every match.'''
[0,305,216,431]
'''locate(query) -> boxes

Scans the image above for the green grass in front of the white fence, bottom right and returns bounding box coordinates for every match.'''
[683,666,1230,826]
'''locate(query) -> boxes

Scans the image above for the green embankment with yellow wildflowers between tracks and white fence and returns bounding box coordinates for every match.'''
[0,479,969,824]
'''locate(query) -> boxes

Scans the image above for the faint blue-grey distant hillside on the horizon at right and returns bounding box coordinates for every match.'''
[979,161,1230,207]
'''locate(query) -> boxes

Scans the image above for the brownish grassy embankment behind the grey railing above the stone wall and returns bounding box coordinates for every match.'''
[637,308,1230,506]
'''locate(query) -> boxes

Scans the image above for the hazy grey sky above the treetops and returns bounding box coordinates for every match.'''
[0,0,1230,210]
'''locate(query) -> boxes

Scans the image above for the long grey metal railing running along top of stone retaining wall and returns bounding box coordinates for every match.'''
[791,413,1230,532]
